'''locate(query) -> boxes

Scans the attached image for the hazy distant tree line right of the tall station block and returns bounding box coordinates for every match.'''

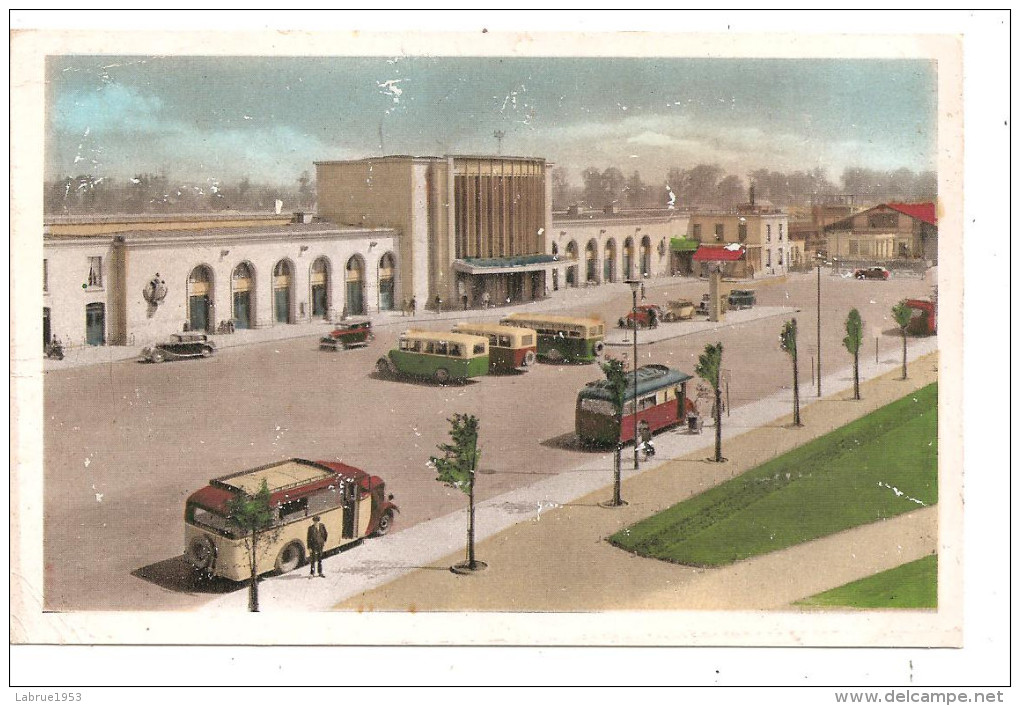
[552,164,936,210]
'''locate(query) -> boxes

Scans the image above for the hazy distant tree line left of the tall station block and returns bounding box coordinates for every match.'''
[43,171,315,215]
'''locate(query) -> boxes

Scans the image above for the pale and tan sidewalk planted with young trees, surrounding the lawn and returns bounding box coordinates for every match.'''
[202,332,937,612]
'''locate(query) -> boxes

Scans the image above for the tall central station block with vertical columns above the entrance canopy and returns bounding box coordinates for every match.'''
[315,156,554,308]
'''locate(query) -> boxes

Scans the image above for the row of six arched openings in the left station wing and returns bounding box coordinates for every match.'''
[188,252,397,332]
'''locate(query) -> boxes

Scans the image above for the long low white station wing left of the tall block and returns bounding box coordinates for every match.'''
[43,217,399,346]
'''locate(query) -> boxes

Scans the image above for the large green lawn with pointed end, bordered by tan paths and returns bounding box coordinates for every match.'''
[609,384,938,566]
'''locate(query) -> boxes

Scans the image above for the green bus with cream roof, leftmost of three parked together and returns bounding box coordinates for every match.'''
[375,329,489,383]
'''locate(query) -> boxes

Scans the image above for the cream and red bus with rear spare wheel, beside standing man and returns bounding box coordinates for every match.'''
[185,458,398,581]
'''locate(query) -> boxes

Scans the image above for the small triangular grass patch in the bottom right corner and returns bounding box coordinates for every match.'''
[797,554,938,608]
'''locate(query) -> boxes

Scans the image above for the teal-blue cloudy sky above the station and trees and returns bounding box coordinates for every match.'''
[46,55,936,185]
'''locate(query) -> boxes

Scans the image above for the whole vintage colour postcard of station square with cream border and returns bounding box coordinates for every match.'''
[10,9,999,685]
